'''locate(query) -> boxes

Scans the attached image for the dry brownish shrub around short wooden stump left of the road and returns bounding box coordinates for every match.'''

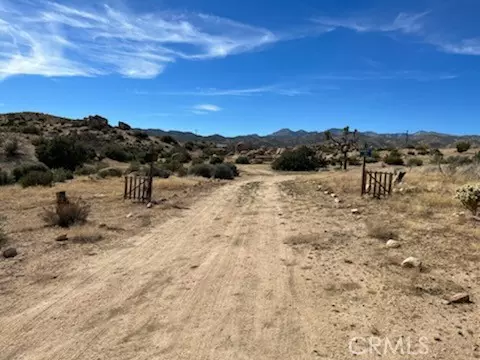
[42,199,90,228]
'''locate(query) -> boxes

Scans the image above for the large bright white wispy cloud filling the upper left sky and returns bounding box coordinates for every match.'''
[0,0,280,78]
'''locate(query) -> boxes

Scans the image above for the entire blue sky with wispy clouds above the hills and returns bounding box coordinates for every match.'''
[0,0,480,135]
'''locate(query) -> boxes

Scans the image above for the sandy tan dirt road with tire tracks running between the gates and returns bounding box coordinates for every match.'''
[0,176,480,360]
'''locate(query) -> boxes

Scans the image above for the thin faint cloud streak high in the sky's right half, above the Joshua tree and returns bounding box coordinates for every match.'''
[313,11,429,34]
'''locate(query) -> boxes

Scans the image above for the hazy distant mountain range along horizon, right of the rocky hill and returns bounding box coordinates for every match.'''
[146,129,480,148]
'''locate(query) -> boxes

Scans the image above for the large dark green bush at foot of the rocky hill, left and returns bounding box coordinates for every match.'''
[35,136,95,171]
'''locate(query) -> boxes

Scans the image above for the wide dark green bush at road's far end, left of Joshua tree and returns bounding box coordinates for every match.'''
[272,146,326,171]
